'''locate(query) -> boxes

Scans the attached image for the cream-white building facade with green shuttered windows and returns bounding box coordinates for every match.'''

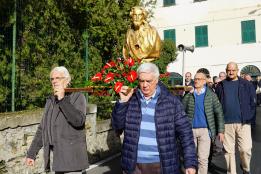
[150,0,261,80]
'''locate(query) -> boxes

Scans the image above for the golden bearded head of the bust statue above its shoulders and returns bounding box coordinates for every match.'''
[130,6,148,27]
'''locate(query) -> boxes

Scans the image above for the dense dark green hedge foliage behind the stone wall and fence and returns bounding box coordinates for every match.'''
[0,0,150,111]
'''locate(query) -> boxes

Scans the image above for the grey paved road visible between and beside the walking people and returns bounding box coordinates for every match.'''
[88,107,261,174]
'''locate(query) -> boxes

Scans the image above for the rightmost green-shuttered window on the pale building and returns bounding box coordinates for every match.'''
[241,20,256,43]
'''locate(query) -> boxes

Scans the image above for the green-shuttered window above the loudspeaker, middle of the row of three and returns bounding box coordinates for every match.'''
[195,25,208,47]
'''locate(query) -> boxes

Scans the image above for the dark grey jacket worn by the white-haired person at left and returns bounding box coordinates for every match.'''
[27,93,89,172]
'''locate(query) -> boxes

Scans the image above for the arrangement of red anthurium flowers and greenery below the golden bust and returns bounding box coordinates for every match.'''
[91,58,140,94]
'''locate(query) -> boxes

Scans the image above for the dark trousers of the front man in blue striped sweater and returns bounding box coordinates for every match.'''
[123,163,161,174]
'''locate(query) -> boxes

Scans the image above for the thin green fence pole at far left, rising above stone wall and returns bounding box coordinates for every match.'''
[11,0,16,112]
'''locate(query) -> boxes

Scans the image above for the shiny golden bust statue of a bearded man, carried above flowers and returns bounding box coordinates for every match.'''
[123,6,161,62]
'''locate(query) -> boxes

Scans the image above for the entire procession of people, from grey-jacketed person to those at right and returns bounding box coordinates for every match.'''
[23,62,260,174]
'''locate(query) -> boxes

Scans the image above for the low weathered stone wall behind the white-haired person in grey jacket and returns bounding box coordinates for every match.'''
[0,104,120,174]
